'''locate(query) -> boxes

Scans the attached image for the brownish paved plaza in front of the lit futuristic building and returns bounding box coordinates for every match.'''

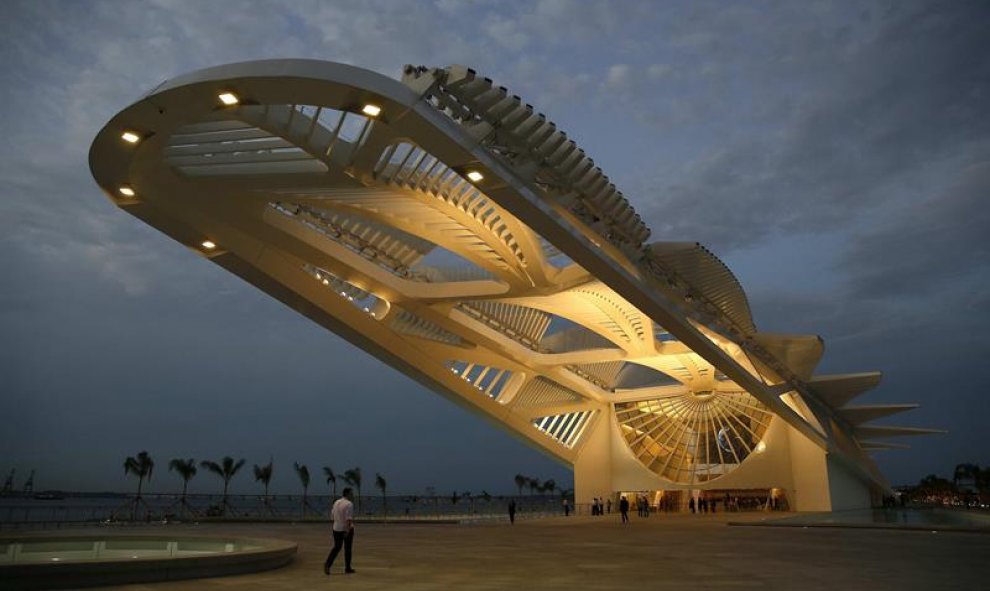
[85,514,990,591]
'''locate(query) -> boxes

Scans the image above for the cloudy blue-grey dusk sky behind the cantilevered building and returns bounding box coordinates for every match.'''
[0,0,990,493]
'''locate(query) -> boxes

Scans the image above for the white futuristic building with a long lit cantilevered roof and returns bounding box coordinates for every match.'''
[90,60,931,510]
